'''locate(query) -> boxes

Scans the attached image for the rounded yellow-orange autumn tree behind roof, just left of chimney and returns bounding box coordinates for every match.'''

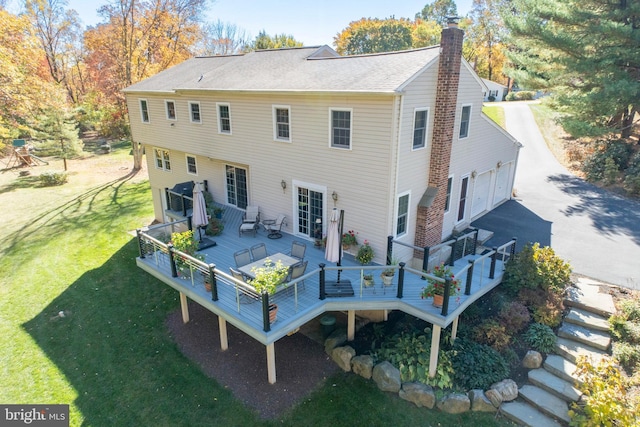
[334,17,413,55]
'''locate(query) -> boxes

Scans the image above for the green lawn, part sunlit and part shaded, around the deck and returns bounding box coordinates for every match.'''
[0,145,507,427]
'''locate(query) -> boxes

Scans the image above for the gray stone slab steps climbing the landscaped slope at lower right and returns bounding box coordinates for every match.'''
[500,279,615,427]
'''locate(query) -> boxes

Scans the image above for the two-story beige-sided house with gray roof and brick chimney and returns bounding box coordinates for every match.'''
[124,24,520,268]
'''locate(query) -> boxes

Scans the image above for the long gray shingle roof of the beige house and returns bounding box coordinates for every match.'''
[125,46,439,93]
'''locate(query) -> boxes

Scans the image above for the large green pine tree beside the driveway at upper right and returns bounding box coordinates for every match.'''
[503,0,640,138]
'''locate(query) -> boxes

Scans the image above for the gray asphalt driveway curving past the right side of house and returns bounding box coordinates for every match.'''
[473,102,640,289]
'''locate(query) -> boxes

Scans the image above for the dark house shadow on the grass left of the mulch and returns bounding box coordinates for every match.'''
[23,239,254,425]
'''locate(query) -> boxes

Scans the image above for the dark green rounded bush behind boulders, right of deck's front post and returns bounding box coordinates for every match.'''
[451,338,509,390]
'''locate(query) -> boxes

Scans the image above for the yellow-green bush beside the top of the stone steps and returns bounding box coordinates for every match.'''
[501,243,571,295]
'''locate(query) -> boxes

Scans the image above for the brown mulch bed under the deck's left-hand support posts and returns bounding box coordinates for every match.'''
[167,302,340,419]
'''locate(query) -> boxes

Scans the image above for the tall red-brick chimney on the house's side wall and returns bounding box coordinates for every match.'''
[415,18,464,249]
